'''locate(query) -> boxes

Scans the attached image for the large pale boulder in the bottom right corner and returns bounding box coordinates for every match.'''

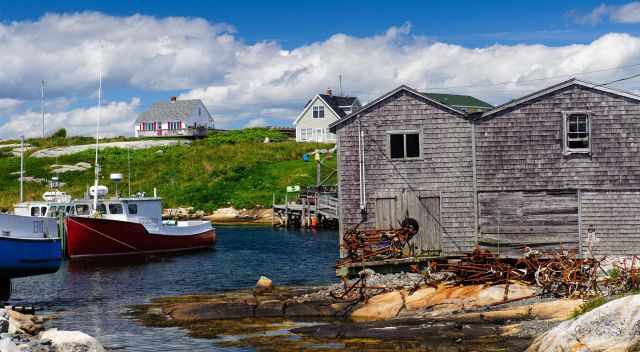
[527,295,640,352]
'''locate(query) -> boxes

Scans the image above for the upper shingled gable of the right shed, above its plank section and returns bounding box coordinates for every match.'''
[476,86,640,191]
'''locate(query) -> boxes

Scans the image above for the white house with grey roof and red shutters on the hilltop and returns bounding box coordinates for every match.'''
[134,97,214,137]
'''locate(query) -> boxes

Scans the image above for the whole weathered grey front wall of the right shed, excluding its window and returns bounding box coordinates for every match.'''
[475,85,640,254]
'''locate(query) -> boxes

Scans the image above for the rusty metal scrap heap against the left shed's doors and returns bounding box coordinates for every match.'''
[338,218,419,266]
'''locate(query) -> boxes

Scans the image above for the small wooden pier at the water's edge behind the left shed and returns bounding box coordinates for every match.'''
[273,191,338,228]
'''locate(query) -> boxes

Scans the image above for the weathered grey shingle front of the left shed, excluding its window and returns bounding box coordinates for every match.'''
[337,91,476,253]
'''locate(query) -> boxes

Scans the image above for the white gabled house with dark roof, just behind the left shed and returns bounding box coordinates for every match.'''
[293,89,361,143]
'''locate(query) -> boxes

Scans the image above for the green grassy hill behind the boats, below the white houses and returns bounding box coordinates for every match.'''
[0,128,336,211]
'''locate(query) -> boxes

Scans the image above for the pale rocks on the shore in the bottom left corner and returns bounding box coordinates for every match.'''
[0,307,104,352]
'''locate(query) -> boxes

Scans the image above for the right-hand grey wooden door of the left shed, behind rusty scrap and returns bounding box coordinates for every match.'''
[402,192,441,255]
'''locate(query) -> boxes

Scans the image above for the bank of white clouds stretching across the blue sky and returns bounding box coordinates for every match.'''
[5,12,640,133]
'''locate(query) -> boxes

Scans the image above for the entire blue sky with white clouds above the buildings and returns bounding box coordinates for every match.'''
[0,0,640,139]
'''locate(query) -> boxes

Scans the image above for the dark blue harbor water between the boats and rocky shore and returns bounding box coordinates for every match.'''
[10,226,338,351]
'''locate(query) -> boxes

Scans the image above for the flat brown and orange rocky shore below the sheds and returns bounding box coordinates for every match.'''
[131,274,583,351]
